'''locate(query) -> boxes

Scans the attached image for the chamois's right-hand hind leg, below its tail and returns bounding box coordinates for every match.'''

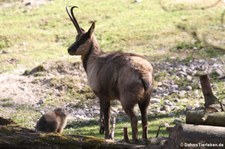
[138,99,150,140]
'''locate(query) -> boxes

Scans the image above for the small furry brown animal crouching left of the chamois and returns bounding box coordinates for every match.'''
[35,108,67,133]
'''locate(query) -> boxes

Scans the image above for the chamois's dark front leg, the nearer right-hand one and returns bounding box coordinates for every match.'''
[100,99,110,139]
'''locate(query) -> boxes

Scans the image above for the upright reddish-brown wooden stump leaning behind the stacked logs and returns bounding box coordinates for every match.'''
[200,75,218,108]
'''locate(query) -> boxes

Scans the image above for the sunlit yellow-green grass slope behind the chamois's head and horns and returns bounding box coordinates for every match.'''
[0,0,224,73]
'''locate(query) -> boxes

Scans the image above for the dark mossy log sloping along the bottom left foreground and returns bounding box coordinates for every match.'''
[0,117,146,149]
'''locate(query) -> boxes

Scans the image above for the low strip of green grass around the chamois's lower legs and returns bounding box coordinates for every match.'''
[64,116,178,140]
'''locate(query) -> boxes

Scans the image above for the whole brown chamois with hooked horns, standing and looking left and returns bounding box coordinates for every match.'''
[66,6,153,142]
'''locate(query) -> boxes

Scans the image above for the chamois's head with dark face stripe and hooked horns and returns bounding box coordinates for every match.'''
[66,6,95,55]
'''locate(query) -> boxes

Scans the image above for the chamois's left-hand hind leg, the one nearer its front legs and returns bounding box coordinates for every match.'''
[121,99,138,143]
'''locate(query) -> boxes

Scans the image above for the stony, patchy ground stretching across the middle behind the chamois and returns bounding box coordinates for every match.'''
[0,57,225,125]
